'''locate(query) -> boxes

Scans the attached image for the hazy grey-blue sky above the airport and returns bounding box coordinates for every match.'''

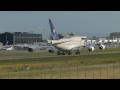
[0,11,120,37]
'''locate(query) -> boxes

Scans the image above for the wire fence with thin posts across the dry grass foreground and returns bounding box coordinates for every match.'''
[0,62,120,79]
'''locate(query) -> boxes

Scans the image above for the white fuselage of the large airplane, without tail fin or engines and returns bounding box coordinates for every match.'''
[52,37,86,51]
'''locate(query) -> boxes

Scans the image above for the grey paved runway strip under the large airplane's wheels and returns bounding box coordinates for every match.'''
[0,51,120,60]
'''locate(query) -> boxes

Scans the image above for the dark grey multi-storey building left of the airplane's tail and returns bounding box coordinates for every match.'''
[0,32,42,45]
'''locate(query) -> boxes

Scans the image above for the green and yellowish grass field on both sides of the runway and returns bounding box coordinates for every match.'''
[0,48,120,79]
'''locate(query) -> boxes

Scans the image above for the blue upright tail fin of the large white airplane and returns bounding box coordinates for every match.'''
[49,19,60,40]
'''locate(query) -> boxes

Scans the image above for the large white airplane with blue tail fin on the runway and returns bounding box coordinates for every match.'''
[47,19,105,55]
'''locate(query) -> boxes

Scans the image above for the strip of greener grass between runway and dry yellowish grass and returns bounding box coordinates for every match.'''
[0,53,120,65]
